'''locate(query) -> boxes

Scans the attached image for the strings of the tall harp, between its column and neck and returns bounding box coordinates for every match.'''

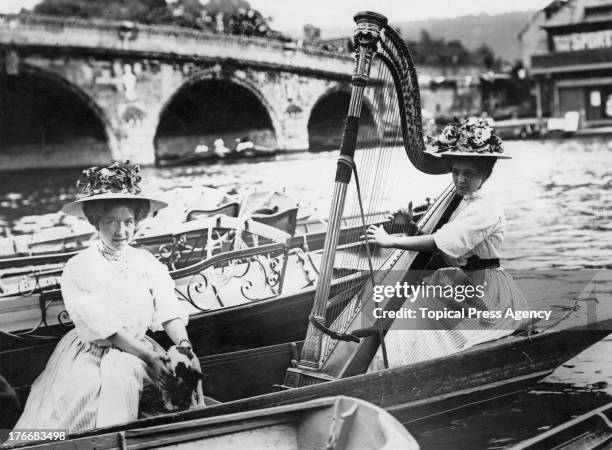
[321,40,406,359]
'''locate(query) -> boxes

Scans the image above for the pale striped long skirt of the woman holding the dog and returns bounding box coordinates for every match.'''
[15,330,154,434]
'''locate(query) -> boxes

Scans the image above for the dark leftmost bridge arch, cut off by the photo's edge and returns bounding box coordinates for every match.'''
[0,63,117,169]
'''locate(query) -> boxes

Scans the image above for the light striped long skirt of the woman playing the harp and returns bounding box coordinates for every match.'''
[368,267,529,372]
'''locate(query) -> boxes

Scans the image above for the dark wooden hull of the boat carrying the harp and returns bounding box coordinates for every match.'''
[15,329,608,449]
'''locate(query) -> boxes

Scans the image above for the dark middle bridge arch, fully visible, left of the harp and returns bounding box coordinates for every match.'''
[154,72,282,159]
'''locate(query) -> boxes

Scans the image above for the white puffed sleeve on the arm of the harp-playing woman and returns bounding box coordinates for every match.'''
[433,202,503,258]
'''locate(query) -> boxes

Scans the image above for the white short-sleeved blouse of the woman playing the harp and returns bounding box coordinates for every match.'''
[433,188,506,266]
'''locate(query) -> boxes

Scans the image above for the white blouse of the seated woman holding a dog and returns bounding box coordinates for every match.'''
[61,244,188,344]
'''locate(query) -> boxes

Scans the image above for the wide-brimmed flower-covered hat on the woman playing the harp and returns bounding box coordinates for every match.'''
[427,117,510,159]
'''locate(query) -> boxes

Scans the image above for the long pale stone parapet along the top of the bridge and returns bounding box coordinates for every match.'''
[0,15,353,78]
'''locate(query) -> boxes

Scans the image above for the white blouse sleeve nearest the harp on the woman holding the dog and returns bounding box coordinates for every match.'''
[148,255,189,331]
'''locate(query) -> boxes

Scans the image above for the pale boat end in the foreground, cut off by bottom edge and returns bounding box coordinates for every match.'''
[0,396,419,450]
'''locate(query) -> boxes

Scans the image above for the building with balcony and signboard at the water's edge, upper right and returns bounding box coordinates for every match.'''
[519,0,612,128]
